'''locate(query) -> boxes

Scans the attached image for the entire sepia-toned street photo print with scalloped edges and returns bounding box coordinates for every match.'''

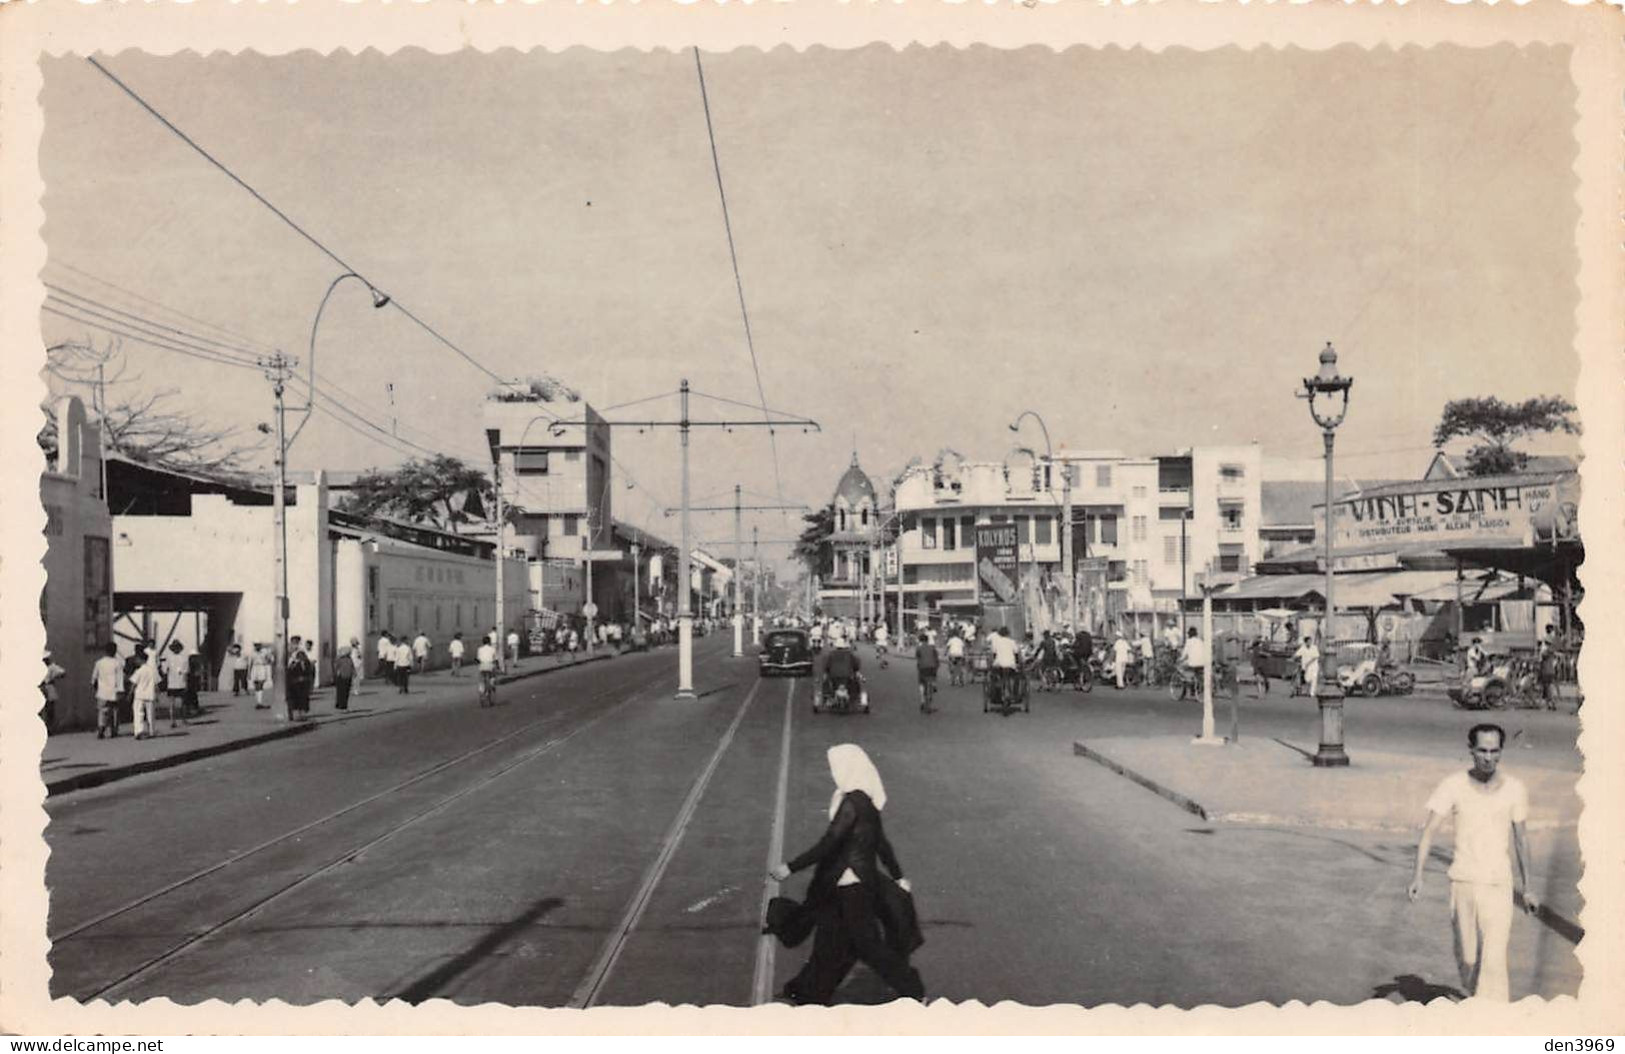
[5,5,1620,1030]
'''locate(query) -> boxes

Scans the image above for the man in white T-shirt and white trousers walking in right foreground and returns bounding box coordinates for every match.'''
[1406,724,1541,1002]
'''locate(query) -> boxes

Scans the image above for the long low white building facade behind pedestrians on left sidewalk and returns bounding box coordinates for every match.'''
[111,466,527,685]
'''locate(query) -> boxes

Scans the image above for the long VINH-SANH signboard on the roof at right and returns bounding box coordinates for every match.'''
[1315,474,1578,552]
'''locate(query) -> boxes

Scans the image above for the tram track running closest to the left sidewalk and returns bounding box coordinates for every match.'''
[50,674,666,1002]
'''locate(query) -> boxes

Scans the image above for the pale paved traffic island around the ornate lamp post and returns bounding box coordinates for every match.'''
[1073,732,1581,940]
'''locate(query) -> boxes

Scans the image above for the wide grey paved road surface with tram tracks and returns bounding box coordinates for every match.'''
[47,635,1578,1005]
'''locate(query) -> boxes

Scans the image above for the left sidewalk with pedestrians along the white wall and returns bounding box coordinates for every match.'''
[39,651,614,797]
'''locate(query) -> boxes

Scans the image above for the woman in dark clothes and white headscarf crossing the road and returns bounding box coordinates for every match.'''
[772,742,925,1005]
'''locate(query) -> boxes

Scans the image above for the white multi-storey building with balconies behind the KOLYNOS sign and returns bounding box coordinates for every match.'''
[895,445,1263,629]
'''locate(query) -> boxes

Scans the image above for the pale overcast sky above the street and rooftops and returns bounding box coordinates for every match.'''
[41,47,1578,568]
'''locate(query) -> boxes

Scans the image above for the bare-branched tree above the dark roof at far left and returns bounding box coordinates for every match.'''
[36,341,258,481]
